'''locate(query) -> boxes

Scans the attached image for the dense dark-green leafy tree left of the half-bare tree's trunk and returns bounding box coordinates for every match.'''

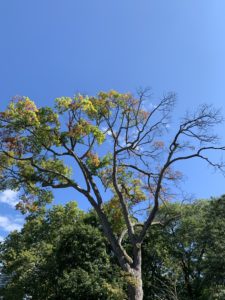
[1,202,124,300]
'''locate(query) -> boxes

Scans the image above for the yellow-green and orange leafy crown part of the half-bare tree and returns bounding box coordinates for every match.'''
[0,90,176,217]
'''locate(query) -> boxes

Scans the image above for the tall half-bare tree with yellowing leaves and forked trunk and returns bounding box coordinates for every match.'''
[0,91,225,299]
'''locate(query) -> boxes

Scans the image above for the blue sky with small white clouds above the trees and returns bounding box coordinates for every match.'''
[0,0,225,239]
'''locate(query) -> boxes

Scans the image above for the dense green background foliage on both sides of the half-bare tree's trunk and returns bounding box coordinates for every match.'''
[1,197,225,300]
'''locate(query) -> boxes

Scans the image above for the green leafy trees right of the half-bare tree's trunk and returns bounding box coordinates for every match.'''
[143,196,225,300]
